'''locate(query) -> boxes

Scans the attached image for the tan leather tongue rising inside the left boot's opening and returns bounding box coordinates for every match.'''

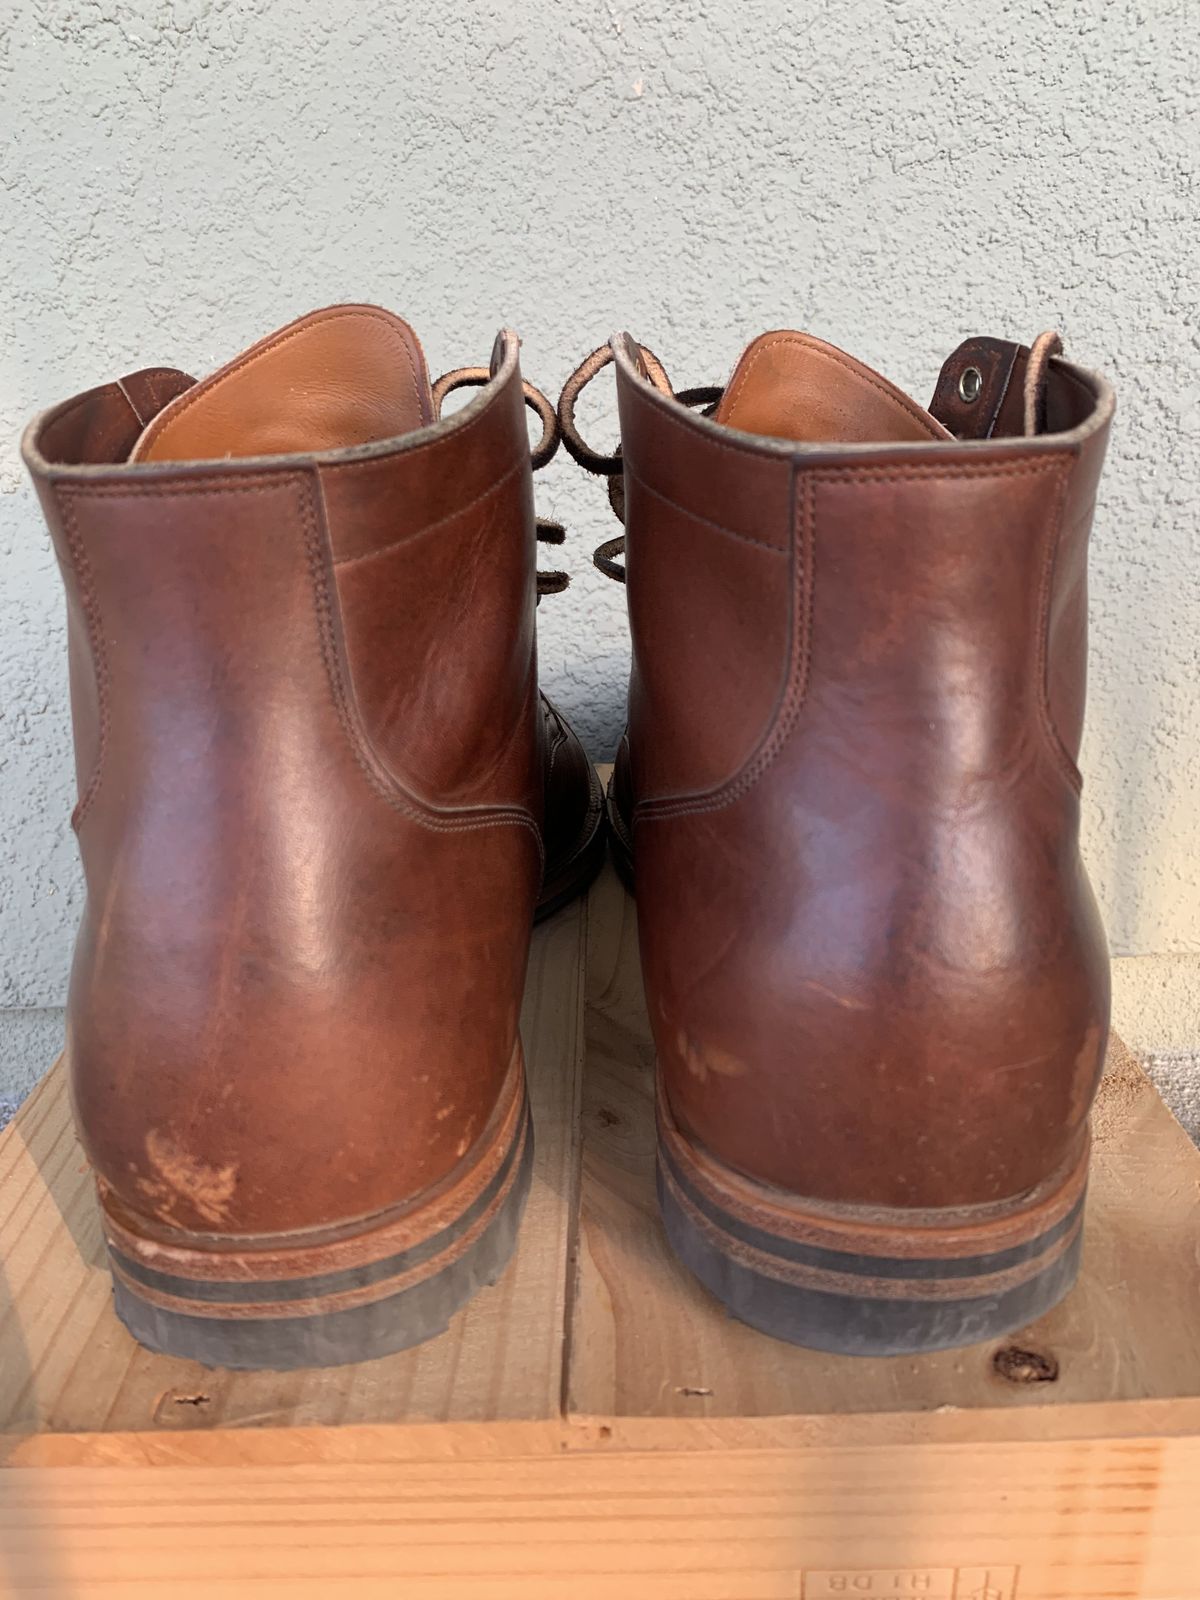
[130,306,434,461]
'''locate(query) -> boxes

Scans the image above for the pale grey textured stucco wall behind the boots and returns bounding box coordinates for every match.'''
[0,0,1200,1086]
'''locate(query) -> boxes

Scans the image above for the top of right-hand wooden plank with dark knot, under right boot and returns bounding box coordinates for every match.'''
[570,869,1200,1420]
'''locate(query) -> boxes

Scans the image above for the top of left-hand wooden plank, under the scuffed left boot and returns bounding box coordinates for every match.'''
[0,904,586,1450]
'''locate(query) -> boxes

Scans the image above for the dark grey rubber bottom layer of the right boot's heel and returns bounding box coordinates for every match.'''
[658,1152,1083,1357]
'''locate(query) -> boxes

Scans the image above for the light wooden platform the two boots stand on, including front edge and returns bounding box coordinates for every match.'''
[0,870,1200,1600]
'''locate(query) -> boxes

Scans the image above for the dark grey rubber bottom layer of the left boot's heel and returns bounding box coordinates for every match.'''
[112,1126,533,1373]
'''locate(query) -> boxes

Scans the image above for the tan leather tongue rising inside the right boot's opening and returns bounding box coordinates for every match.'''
[715,333,950,445]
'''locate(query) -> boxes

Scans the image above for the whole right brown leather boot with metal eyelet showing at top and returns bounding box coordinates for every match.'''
[560,333,1114,1355]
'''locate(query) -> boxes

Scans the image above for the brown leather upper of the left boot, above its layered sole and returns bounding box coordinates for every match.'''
[26,314,542,1232]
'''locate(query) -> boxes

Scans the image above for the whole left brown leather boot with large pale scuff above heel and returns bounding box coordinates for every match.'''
[24,306,603,1368]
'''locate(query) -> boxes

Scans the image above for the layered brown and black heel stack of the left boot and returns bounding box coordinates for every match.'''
[101,1082,533,1371]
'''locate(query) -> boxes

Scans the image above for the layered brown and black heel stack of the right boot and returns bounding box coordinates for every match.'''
[658,1088,1088,1355]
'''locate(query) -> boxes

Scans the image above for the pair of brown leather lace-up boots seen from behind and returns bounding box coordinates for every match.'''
[24,306,1112,1368]
